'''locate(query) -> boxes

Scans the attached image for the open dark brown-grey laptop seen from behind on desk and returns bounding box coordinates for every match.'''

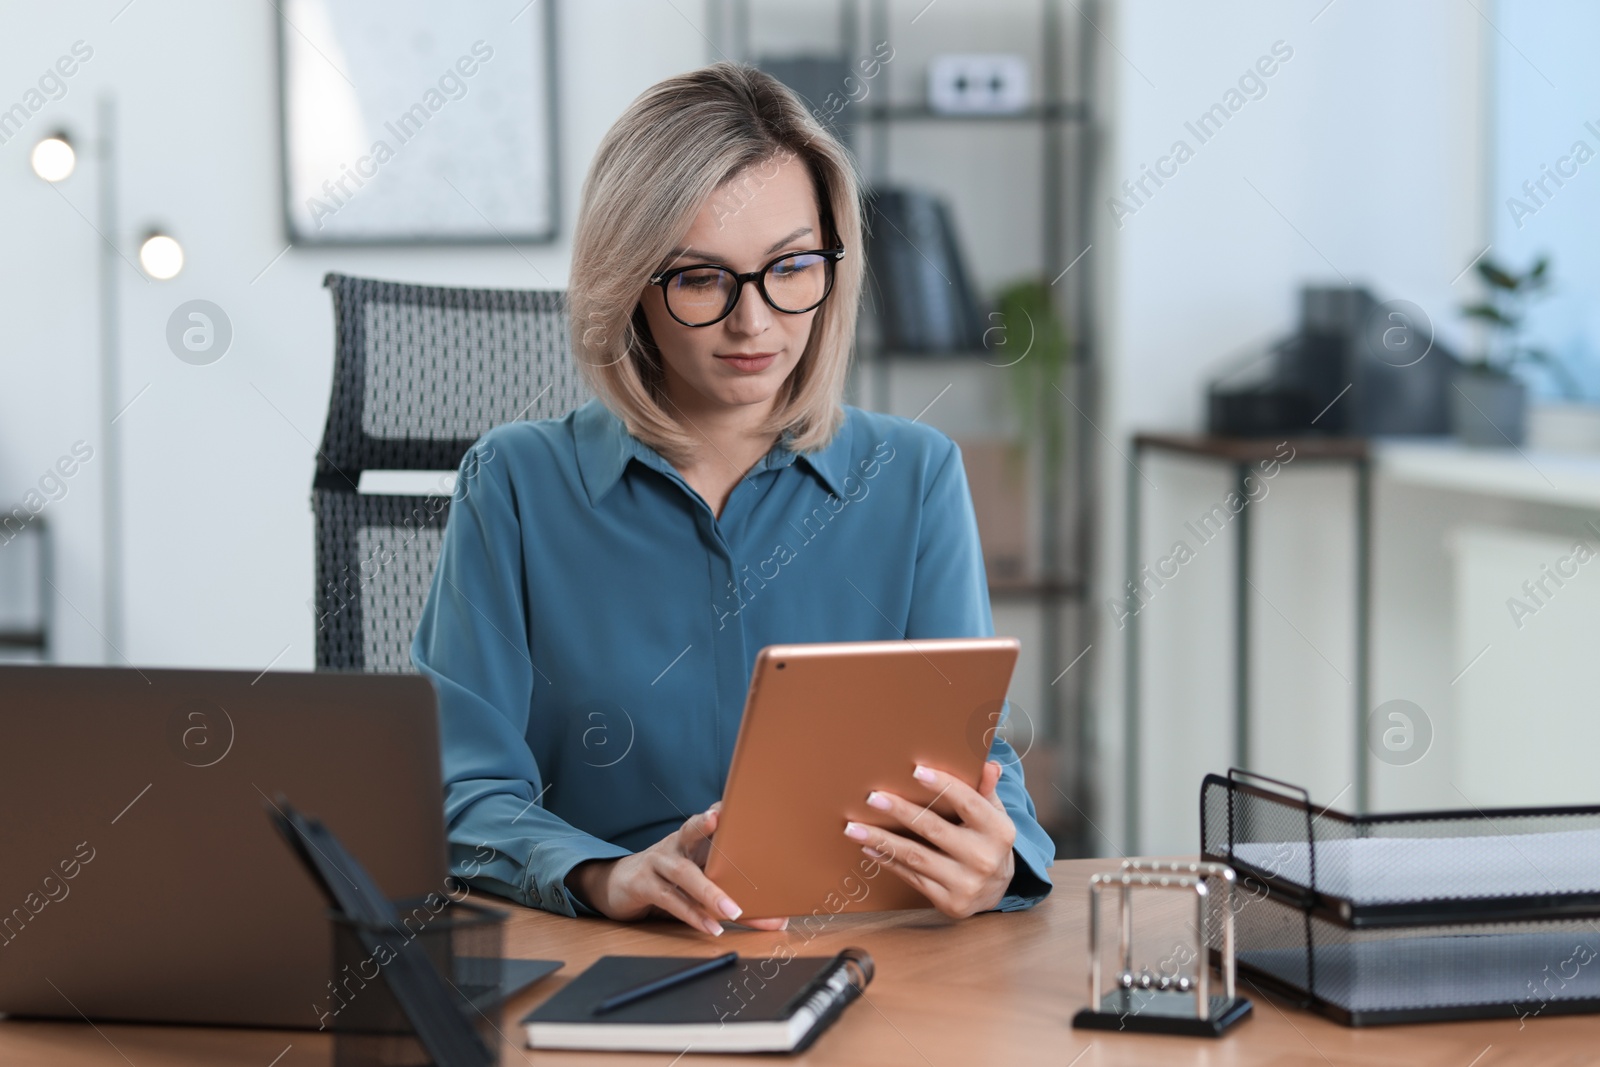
[0,665,560,1030]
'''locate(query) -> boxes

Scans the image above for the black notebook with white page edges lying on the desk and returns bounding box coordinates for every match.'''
[522,949,872,1053]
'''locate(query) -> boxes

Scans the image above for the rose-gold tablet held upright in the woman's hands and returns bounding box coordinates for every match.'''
[706,637,1019,918]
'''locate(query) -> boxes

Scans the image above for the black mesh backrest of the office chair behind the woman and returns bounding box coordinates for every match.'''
[309,274,590,672]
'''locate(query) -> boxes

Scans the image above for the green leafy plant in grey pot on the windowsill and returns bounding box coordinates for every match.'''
[1450,256,1578,445]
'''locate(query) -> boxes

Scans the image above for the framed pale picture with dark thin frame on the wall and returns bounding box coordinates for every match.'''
[275,0,558,245]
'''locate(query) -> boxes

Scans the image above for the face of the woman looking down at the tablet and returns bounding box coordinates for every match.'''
[640,152,827,413]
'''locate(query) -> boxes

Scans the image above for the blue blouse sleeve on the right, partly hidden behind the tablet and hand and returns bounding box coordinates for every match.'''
[906,442,1056,912]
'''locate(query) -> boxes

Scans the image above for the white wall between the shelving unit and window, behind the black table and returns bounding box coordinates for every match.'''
[1085,0,1491,854]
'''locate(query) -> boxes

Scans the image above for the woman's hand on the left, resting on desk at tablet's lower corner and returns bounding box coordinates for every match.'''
[566,801,789,936]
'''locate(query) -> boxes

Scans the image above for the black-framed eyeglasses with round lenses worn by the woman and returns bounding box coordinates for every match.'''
[650,248,845,326]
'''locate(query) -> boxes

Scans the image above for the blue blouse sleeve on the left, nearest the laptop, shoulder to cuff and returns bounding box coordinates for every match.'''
[411,434,629,915]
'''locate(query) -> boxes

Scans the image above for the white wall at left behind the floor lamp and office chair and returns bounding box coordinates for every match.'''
[0,0,707,669]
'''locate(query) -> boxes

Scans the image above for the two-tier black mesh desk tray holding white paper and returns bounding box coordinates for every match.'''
[1200,769,1600,1025]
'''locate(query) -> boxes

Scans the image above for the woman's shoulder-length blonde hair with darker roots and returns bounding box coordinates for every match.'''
[568,62,862,462]
